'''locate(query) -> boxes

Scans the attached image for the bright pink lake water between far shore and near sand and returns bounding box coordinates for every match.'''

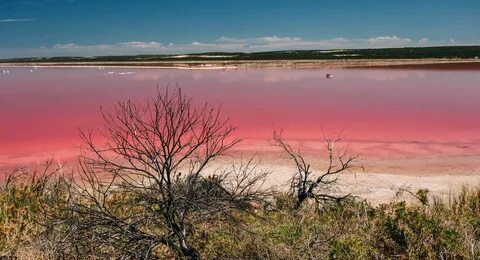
[0,68,480,166]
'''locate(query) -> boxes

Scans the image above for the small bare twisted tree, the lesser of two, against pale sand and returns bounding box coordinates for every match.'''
[273,131,358,210]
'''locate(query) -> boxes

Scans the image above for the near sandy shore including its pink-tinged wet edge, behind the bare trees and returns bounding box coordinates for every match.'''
[0,139,480,204]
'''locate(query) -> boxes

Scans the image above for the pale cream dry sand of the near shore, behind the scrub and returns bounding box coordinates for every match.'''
[0,153,480,205]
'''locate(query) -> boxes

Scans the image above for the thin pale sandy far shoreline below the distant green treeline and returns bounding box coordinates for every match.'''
[0,59,480,70]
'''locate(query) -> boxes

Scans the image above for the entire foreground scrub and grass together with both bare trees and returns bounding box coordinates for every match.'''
[0,90,480,259]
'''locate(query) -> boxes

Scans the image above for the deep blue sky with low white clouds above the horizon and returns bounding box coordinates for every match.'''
[0,0,480,57]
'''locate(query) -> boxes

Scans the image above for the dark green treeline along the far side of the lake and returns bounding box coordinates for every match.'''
[0,46,480,63]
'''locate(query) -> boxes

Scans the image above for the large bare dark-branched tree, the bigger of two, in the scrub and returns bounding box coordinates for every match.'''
[46,89,267,259]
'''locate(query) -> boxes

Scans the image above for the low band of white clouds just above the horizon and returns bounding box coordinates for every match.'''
[0,35,478,57]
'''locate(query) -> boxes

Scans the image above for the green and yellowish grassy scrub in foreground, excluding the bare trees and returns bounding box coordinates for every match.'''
[0,172,480,259]
